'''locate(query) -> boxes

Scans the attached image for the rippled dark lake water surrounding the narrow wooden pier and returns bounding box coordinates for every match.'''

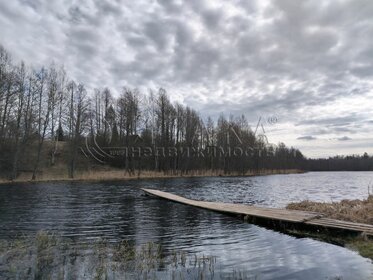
[0,172,373,279]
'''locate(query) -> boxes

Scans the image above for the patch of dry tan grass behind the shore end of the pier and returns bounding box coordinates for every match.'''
[286,195,373,225]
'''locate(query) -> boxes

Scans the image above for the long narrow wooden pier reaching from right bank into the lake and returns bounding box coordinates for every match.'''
[142,189,373,238]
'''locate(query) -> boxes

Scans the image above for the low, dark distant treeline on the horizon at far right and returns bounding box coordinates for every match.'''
[303,153,373,171]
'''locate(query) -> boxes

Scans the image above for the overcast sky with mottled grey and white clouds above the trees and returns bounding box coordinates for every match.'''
[0,0,373,157]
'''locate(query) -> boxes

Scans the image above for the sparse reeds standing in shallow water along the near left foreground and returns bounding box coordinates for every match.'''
[0,231,232,279]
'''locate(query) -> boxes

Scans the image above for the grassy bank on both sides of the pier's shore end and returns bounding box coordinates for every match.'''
[286,195,373,260]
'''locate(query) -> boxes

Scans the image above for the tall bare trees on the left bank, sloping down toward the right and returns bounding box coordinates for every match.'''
[0,43,304,179]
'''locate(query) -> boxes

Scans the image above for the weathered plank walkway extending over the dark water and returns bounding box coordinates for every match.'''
[142,189,373,236]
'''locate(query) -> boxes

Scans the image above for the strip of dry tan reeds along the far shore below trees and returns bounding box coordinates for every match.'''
[0,169,305,185]
